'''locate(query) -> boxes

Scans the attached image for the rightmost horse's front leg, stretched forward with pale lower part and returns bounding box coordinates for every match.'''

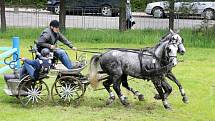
[166,72,189,103]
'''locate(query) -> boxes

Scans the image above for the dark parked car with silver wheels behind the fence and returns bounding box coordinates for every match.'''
[47,0,120,16]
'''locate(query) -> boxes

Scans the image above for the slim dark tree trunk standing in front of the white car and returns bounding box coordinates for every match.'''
[169,0,175,30]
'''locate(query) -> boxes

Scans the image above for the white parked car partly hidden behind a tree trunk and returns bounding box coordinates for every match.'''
[145,0,215,19]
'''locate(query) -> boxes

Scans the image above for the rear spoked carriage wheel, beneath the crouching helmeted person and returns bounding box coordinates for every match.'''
[18,80,50,107]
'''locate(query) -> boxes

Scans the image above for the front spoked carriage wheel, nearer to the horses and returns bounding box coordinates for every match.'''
[51,76,84,105]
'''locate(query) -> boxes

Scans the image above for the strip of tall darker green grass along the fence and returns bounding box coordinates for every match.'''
[0,28,215,48]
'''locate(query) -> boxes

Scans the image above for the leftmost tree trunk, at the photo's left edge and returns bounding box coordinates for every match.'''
[0,0,6,32]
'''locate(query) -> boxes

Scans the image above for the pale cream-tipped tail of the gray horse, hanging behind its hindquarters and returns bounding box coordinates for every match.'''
[89,55,101,89]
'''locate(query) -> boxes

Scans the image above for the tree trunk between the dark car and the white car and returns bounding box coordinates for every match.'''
[119,0,127,31]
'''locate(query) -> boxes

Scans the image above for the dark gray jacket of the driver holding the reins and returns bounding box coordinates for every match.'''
[36,28,73,52]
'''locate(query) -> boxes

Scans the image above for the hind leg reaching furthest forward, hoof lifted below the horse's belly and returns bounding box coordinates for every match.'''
[121,74,144,101]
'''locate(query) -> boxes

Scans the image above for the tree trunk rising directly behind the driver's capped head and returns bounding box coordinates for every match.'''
[59,0,66,32]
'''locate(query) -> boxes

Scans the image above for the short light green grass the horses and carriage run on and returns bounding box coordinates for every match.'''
[0,29,215,121]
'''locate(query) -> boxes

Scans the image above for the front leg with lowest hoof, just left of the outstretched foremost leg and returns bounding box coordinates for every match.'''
[152,79,171,109]
